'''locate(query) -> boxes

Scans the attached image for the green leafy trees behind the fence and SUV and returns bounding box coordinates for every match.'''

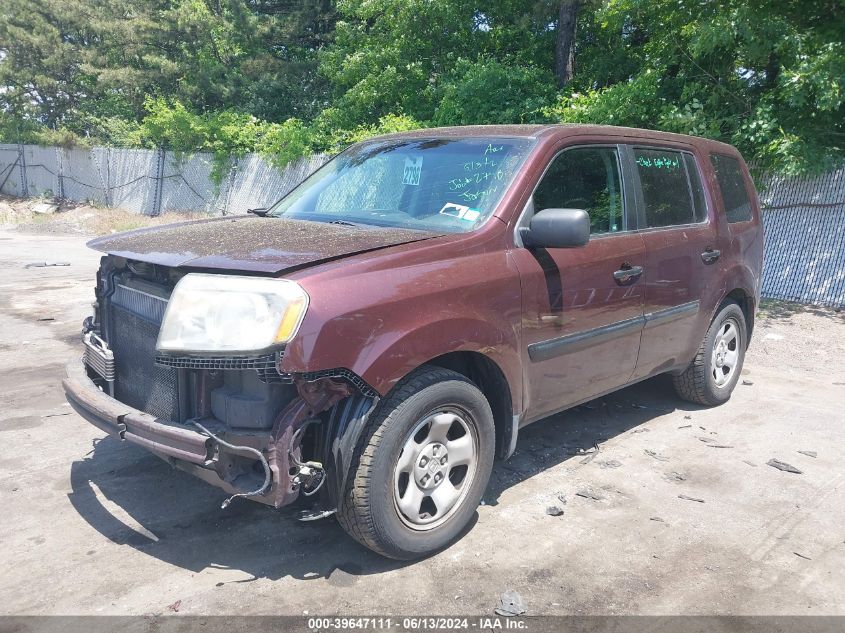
[0,0,845,178]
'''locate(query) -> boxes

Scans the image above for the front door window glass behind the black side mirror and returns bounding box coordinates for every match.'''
[534,147,625,234]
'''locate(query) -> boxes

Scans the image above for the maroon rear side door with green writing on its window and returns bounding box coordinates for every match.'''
[627,146,723,379]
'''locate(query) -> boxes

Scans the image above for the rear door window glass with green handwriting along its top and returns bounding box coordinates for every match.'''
[634,148,696,227]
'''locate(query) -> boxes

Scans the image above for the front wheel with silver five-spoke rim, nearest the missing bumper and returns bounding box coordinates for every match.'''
[337,366,495,560]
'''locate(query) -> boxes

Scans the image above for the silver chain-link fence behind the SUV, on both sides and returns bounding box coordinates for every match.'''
[0,144,845,306]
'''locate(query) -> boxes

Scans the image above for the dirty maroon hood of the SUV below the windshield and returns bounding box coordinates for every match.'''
[88,216,439,273]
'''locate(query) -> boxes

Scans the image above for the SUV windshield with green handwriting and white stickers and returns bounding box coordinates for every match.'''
[268,138,532,233]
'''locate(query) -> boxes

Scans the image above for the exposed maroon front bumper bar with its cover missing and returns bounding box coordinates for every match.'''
[62,361,298,508]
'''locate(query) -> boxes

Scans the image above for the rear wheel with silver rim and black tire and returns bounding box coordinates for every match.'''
[672,301,748,407]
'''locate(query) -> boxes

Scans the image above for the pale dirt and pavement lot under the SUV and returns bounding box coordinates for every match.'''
[0,225,845,615]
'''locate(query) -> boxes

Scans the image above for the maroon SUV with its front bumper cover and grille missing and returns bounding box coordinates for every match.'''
[64,126,763,558]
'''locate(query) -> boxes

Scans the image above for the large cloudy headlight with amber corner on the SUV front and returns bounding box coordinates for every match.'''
[156,273,308,352]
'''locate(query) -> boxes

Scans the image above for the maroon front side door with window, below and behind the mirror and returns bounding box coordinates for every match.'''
[513,145,645,422]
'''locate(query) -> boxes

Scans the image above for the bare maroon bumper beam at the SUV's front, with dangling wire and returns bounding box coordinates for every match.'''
[62,361,296,508]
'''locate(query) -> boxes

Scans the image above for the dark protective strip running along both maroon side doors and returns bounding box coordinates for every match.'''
[528,300,700,363]
